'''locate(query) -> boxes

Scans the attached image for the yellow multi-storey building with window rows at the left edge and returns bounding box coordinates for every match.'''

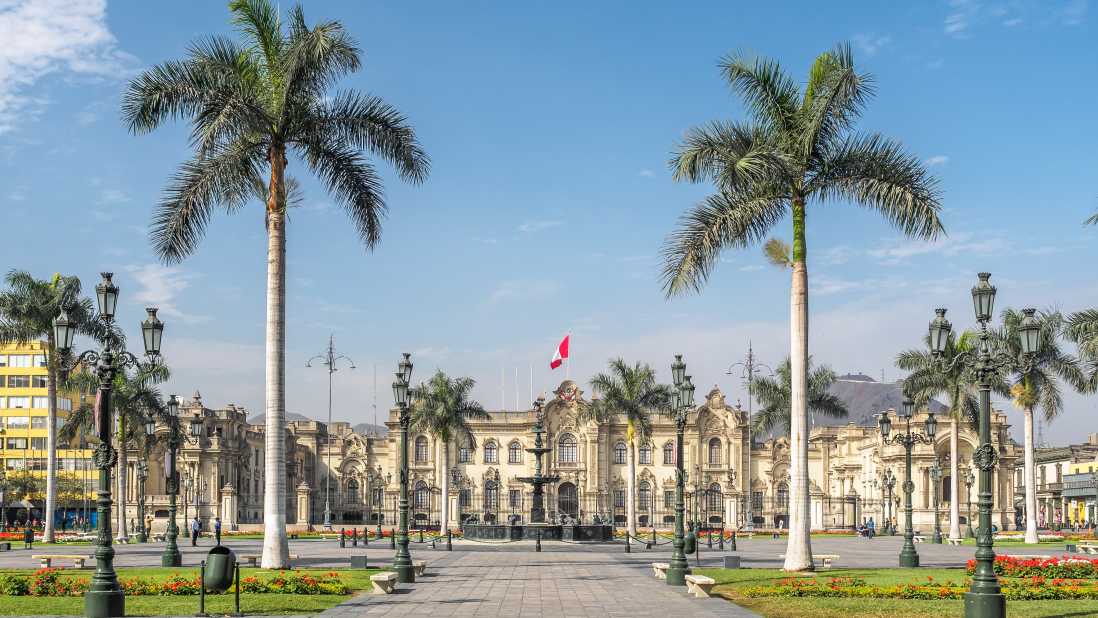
[0,341,94,525]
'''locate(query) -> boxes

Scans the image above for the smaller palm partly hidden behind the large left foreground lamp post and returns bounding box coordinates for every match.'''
[58,362,170,539]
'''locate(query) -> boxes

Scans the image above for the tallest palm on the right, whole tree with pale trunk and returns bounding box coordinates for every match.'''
[662,45,942,571]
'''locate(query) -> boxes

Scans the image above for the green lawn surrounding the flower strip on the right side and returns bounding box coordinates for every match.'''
[696,569,1098,618]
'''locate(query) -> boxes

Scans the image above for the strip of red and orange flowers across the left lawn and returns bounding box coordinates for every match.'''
[0,569,350,596]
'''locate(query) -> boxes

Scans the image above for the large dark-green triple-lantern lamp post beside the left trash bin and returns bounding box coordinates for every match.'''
[54,272,164,618]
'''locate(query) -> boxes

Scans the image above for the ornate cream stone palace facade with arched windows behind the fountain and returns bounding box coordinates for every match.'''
[127,381,1020,531]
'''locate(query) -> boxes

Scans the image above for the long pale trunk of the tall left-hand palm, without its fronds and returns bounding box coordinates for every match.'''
[262,147,290,569]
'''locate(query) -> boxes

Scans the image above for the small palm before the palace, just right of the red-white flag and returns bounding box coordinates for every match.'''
[589,358,671,536]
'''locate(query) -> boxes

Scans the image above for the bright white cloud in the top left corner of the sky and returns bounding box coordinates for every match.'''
[0,0,133,134]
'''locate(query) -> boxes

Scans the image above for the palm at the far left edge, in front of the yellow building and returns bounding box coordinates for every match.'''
[0,270,97,542]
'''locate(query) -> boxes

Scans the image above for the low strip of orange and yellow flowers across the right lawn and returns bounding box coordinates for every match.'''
[740,577,1098,600]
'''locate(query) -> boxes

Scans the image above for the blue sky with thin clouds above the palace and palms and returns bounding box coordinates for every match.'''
[0,0,1098,442]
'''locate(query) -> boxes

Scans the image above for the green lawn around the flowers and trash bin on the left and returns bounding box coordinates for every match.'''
[0,568,382,616]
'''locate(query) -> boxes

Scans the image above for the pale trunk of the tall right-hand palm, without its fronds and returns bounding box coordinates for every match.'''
[782,199,813,571]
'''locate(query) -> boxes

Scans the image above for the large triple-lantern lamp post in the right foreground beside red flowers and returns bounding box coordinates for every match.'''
[929,272,1041,618]
